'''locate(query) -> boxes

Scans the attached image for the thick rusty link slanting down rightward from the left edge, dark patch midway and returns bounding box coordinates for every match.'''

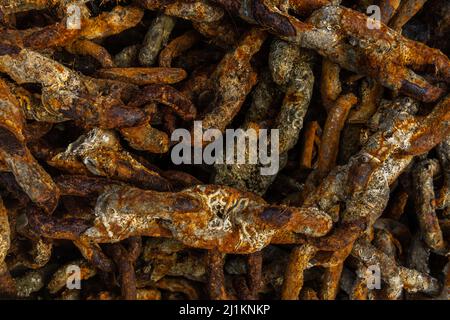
[0,79,59,213]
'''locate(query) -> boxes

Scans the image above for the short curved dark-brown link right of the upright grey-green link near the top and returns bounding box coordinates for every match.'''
[159,31,200,68]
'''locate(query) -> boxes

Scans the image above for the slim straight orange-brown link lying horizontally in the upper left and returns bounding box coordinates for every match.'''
[97,67,187,86]
